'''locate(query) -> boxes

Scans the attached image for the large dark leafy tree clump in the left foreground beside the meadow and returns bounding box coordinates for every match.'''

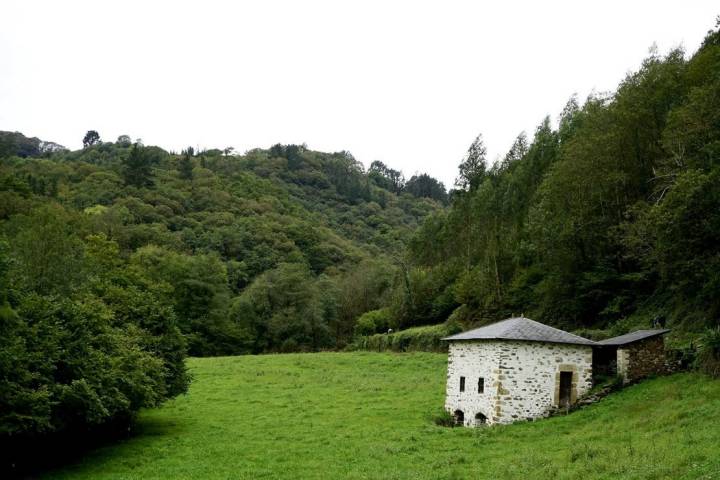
[0,220,189,464]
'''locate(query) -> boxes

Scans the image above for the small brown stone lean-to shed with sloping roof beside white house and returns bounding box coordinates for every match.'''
[593,329,670,383]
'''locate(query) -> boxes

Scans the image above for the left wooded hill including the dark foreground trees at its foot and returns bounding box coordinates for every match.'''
[0,131,447,450]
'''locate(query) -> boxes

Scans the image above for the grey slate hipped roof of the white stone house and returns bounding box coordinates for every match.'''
[443,317,595,345]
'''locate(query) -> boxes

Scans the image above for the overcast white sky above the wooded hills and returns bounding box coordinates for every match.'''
[0,0,720,186]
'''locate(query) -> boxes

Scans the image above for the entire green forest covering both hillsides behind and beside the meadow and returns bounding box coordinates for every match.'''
[0,21,720,462]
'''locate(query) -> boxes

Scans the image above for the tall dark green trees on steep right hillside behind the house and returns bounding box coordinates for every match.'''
[391,23,720,333]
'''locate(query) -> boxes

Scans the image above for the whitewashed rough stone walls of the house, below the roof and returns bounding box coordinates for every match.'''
[445,340,592,426]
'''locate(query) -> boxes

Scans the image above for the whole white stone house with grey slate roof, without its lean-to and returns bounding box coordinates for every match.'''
[444,317,594,426]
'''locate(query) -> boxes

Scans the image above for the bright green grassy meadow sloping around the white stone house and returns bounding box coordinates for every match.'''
[47,352,720,479]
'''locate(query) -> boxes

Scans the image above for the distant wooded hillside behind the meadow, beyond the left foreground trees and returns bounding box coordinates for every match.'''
[0,133,444,355]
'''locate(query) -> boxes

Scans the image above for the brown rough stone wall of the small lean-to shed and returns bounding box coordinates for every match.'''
[617,335,666,382]
